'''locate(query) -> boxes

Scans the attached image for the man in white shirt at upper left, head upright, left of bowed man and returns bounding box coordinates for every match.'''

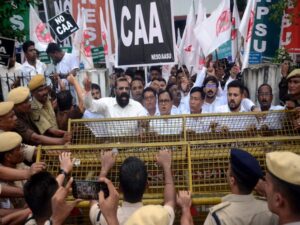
[21,41,47,82]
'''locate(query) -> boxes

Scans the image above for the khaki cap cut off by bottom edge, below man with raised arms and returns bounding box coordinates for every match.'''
[125,205,170,225]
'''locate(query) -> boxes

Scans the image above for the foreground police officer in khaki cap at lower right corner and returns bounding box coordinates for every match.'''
[265,152,300,225]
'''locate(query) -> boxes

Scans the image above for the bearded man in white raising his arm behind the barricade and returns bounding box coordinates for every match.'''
[84,77,146,118]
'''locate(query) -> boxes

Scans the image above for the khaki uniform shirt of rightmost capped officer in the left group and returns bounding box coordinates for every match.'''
[30,98,58,134]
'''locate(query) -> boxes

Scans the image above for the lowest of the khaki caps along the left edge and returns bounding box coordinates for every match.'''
[0,132,22,152]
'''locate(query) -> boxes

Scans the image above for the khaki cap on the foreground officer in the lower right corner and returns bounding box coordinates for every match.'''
[266,152,300,185]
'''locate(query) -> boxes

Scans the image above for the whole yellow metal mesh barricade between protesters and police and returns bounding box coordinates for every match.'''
[37,111,300,224]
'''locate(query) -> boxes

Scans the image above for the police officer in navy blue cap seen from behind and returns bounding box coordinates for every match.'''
[204,149,277,225]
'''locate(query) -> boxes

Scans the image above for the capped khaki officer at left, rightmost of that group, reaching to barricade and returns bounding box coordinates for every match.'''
[28,75,66,137]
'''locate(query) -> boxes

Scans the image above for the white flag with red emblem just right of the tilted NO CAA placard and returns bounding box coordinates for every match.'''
[72,4,94,69]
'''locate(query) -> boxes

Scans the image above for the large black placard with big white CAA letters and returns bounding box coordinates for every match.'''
[110,0,175,66]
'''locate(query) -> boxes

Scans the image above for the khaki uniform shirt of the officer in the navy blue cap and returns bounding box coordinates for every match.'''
[204,194,278,225]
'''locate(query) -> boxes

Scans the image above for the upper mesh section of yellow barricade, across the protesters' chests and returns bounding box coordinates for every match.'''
[69,111,299,145]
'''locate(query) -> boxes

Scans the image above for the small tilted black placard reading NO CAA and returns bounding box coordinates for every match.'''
[48,10,79,41]
